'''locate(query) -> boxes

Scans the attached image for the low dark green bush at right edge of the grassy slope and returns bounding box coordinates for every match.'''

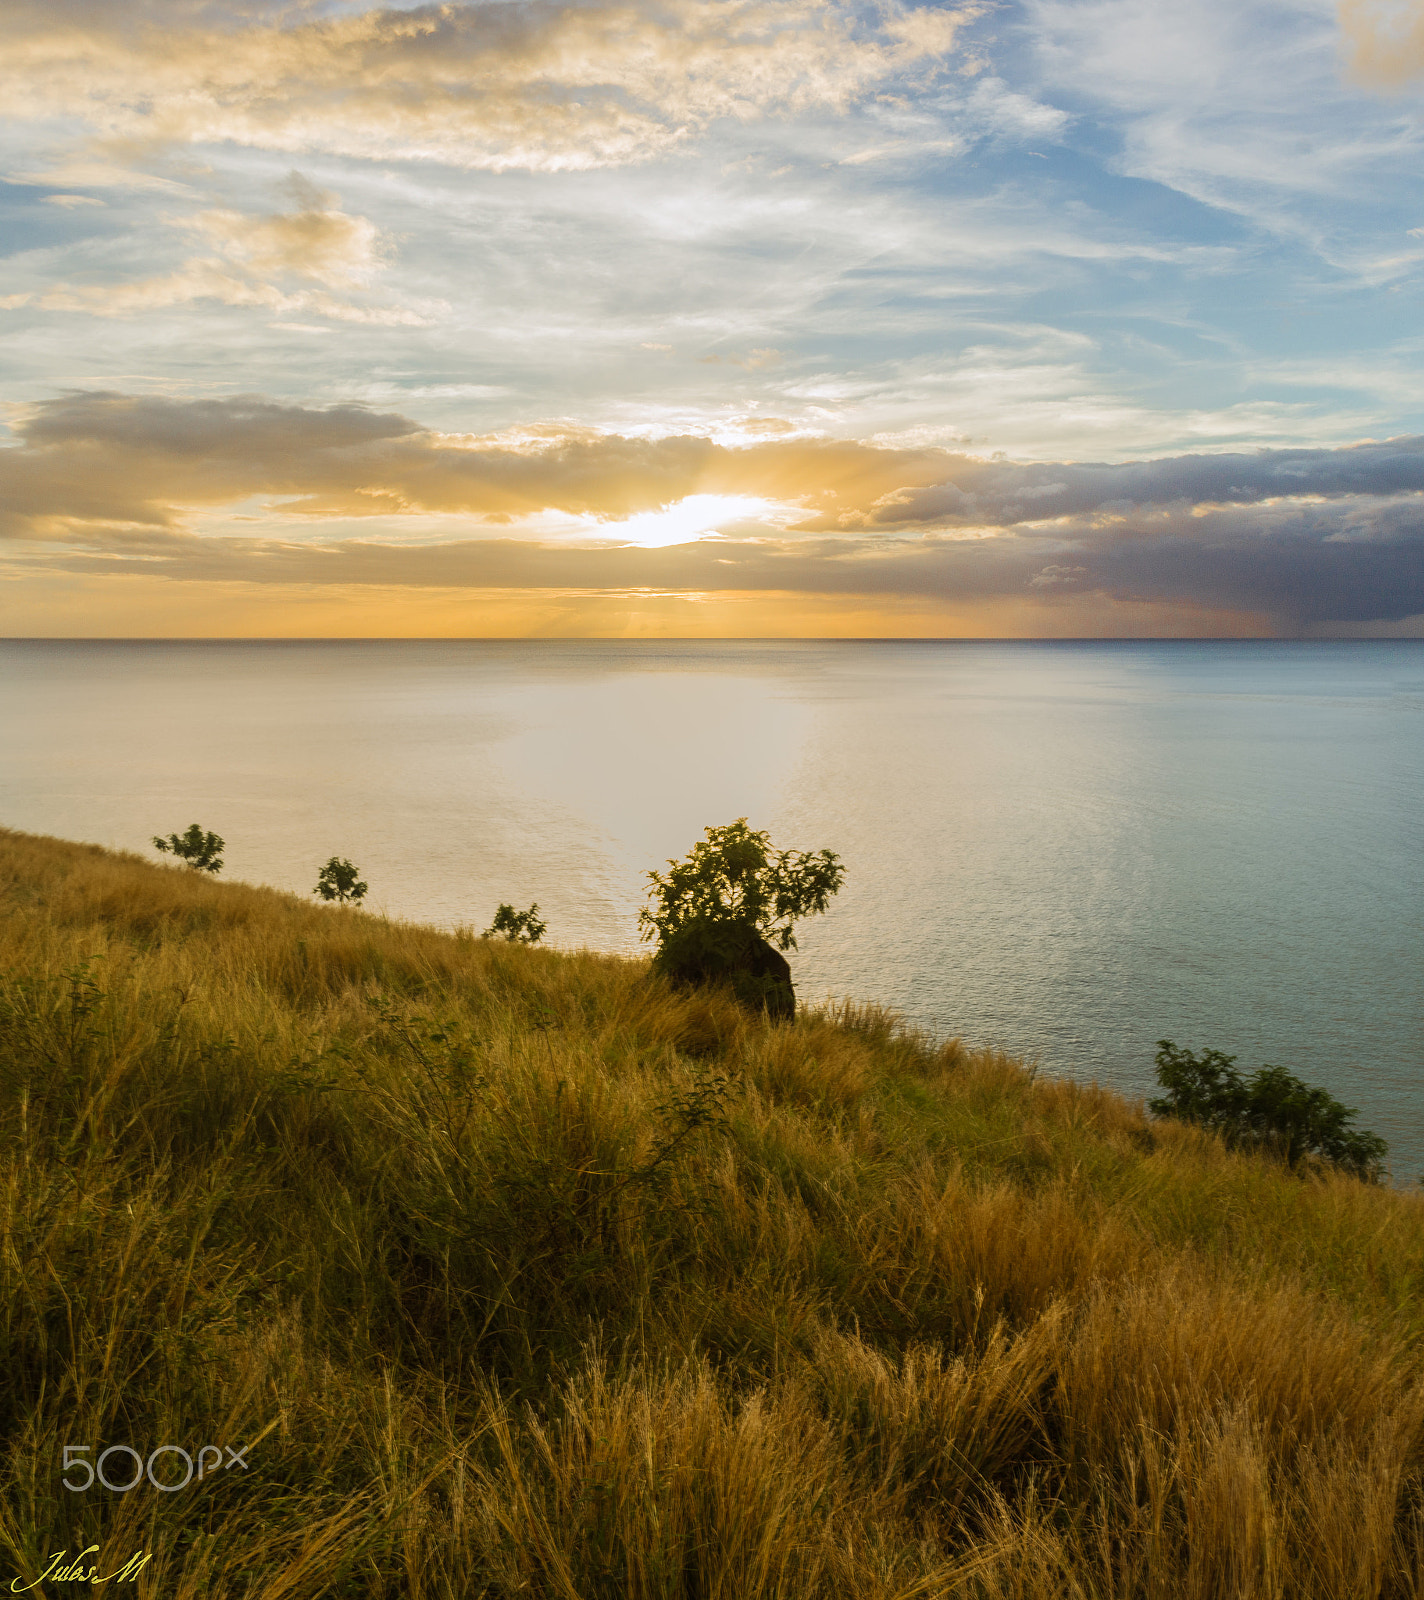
[1147,1038,1389,1182]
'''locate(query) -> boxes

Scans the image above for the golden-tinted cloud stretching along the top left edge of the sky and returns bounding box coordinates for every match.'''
[0,0,976,171]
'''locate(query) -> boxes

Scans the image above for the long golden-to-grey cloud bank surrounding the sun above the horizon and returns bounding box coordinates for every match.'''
[0,394,1424,632]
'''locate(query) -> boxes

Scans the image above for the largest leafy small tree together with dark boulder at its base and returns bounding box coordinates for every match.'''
[638,816,845,1016]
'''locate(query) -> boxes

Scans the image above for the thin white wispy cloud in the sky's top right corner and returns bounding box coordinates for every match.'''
[1022,0,1424,283]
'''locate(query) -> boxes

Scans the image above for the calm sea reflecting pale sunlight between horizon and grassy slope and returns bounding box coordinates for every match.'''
[0,642,1424,1178]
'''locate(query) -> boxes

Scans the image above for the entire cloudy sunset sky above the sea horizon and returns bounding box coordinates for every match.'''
[0,0,1424,638]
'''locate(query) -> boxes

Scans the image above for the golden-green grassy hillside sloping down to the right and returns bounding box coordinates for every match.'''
[0,832,1424,1600]
